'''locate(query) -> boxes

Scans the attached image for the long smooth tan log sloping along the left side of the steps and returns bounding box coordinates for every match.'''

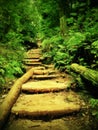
[0,68,34,129]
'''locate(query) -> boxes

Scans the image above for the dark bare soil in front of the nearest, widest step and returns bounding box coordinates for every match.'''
[4,109,98,130]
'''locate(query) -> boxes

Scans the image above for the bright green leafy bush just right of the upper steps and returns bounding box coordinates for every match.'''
[42,32,85,70]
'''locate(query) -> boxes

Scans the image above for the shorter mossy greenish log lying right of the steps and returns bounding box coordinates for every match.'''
[71,63,98,85]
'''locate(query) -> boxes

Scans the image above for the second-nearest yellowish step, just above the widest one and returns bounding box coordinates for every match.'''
[22,80,71,93]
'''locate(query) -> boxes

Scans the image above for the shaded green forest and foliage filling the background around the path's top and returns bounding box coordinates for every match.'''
[0,0,98,118]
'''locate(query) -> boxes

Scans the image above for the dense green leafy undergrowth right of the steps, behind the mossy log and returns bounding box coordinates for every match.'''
[42,8,98,118]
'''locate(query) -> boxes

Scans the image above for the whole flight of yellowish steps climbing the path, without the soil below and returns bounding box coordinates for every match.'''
[11,49,81,118]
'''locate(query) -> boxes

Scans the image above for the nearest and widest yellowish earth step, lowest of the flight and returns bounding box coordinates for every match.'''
[11,92,81,117]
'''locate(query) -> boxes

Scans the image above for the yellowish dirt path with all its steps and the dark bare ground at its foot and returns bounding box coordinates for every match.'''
[0,46,98,130]
